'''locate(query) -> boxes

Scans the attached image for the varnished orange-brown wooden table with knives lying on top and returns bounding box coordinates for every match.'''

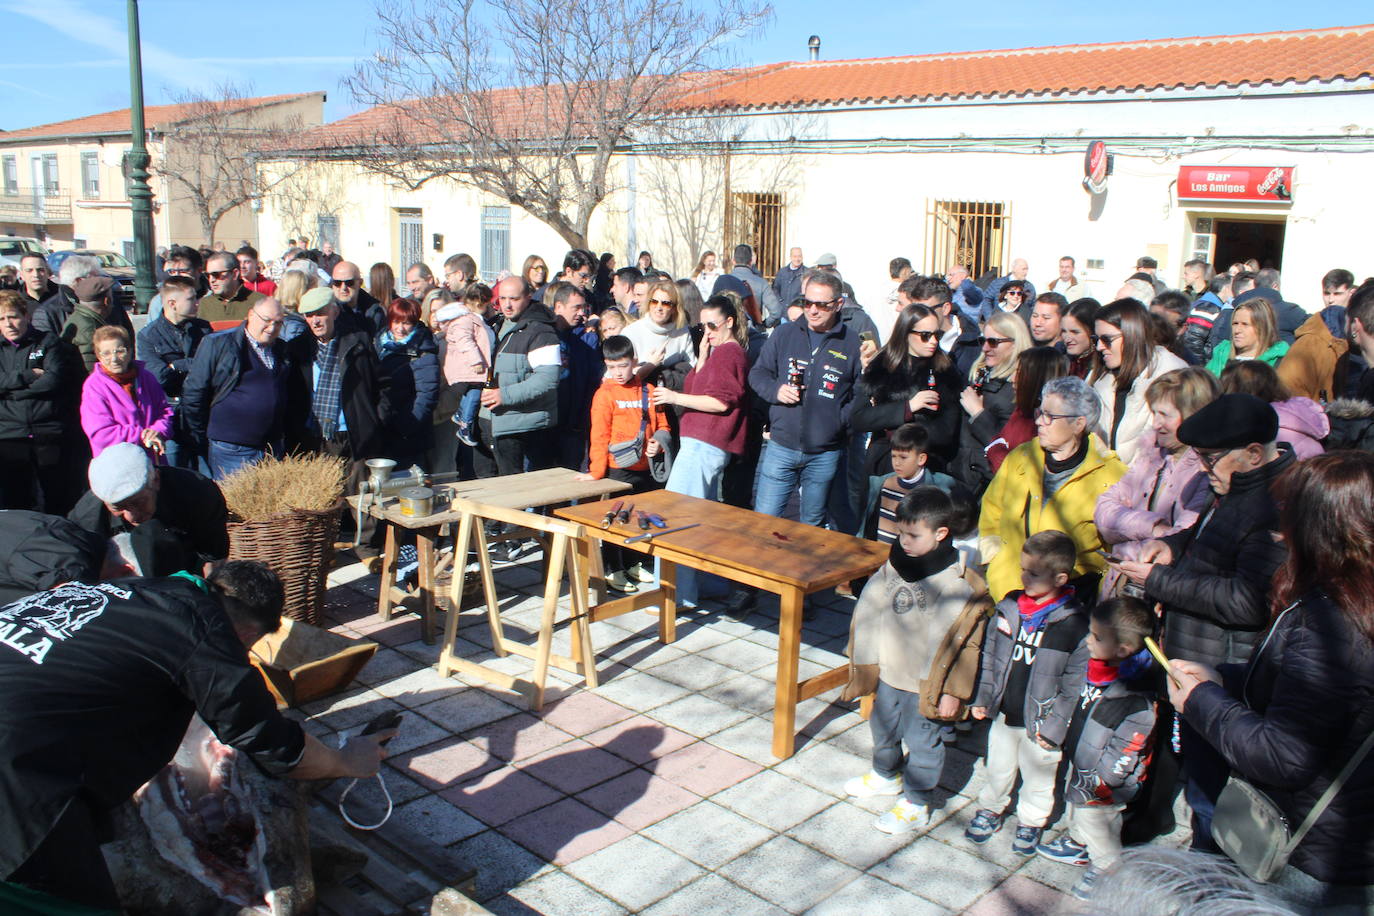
[555,490,889,758]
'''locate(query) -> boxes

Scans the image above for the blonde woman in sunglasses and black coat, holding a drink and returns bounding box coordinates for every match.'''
[949,312,1032,493]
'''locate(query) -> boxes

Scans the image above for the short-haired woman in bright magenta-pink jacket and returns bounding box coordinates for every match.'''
[81,324,176,464]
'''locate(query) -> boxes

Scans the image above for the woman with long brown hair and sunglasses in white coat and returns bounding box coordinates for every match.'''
[1088,299,1187,464]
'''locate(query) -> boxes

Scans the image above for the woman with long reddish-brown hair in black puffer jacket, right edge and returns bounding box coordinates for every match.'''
[1169,452,1374,913]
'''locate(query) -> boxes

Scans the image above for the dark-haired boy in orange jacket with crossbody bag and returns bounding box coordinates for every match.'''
[577,335,668,593]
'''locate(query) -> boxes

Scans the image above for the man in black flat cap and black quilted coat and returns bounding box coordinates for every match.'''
[1116,394,1294,851]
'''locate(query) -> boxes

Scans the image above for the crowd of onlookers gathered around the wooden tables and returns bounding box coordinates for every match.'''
[0,238,1374,912]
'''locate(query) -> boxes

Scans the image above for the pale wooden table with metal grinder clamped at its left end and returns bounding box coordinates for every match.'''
[348,467,629,644]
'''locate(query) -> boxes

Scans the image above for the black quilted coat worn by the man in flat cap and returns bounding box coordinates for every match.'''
[1145,446,1294,665]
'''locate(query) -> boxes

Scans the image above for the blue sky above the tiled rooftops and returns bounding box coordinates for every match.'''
[0,0,1374,129]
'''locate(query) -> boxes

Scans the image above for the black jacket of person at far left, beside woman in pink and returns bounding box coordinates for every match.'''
[0,327,81,439]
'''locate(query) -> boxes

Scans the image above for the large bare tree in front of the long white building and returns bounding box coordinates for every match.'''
[348,0,772,247]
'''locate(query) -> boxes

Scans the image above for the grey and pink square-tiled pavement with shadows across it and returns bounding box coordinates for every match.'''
[304,554,1187,916]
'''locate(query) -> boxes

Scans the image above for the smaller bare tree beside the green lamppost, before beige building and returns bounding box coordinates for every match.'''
[153,85,302,244]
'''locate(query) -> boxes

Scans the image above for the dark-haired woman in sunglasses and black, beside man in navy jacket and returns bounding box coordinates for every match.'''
[849,305,963,477]
